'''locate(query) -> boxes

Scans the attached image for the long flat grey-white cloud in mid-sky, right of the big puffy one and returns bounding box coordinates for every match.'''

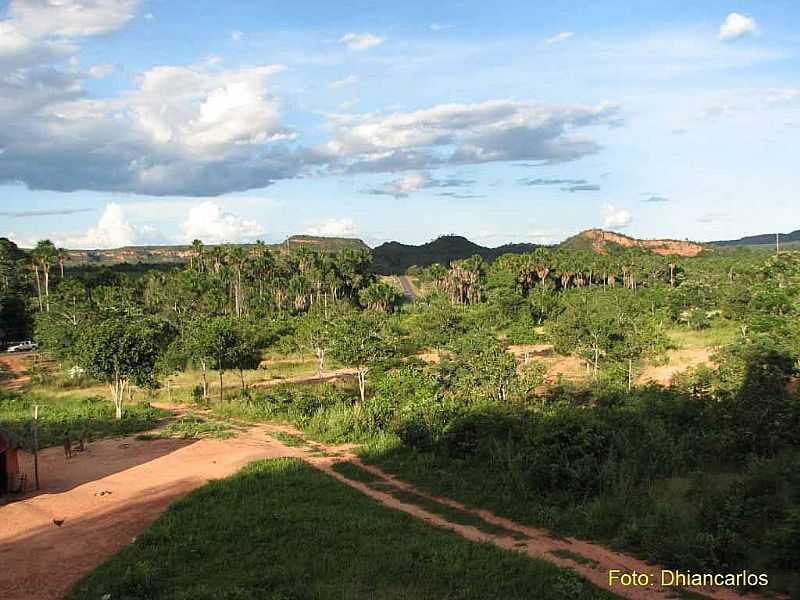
[316,100,620,172]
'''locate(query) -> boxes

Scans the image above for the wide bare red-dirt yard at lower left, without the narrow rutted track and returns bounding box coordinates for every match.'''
[0,427,308,600]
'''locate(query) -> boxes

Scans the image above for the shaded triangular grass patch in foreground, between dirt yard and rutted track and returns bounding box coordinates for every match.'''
[67,459,613,600]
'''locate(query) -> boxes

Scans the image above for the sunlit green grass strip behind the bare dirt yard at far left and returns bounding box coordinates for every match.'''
[0,392,171,448]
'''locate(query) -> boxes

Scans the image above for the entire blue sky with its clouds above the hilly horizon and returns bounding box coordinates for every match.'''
[0,0,800,247]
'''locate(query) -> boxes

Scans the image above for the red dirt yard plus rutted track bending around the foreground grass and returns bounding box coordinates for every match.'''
[0,407,764,600]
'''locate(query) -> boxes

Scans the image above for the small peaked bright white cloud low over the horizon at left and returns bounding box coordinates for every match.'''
[54,202,161,250]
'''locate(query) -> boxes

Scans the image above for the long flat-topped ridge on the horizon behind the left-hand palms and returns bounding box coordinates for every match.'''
[69,235,368,265]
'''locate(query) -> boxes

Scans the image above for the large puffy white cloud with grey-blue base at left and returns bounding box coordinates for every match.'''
[0,59,300,196]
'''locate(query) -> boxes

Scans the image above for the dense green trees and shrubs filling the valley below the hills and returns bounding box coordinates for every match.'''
[1,232,800,593]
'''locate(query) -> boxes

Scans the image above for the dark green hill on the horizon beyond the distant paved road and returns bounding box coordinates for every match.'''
[372,235,539,274]
